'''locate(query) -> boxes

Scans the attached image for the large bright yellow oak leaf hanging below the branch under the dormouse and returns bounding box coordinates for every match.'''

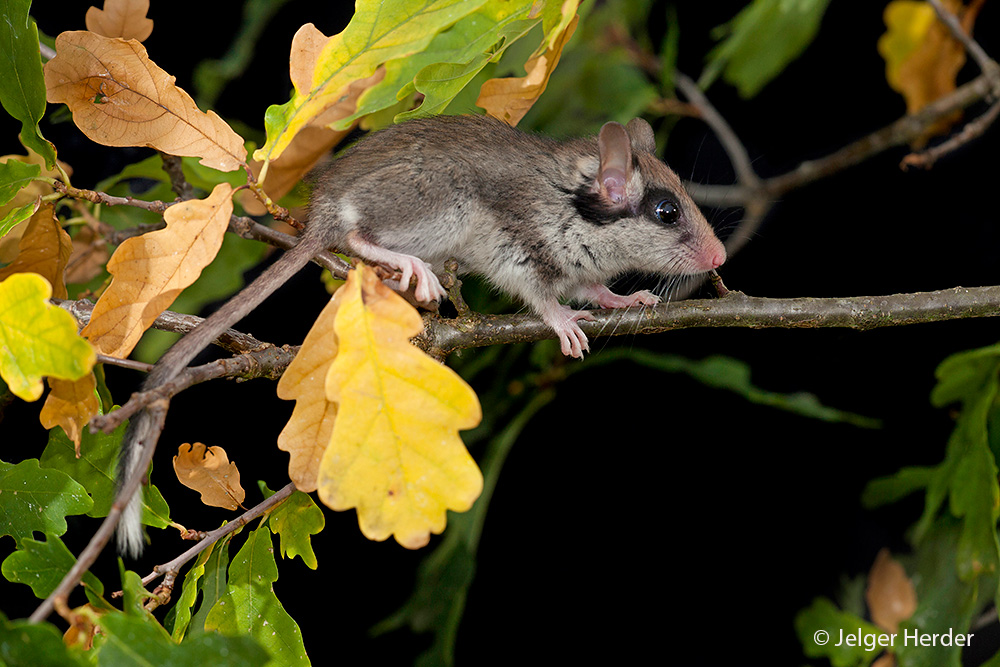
[318,265,483,549]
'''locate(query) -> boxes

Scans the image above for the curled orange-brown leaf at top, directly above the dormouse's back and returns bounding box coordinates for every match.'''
[476,11,580,125]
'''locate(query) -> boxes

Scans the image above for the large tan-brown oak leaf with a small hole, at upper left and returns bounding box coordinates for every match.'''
[45,30,246,171]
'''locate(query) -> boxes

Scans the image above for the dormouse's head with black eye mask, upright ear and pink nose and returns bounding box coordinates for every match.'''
[581,118,726,274]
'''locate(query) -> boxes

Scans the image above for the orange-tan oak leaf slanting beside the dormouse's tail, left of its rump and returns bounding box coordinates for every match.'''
[83,183,233,358]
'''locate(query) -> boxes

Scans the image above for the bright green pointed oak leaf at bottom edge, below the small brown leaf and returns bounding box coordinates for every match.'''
[205,526,309,665]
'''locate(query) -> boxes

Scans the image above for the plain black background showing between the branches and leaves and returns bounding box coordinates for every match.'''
[0,0,1000,665]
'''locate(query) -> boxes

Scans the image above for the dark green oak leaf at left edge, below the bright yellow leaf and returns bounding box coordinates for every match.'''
[0,459,94,542]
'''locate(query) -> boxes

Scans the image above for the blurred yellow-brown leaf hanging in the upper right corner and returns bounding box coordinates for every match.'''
[878,0,982,148]
